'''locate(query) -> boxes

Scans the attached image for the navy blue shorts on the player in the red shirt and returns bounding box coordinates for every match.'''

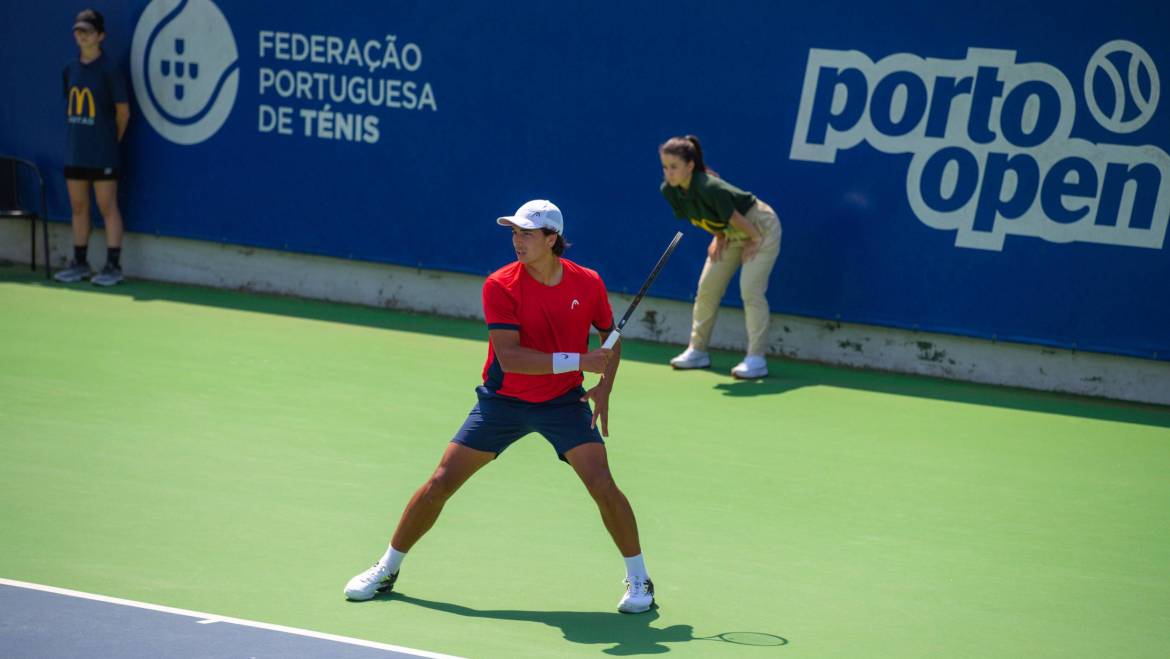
[452,386,605,461]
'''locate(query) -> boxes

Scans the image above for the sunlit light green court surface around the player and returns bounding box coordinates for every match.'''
[0,268,1170,659]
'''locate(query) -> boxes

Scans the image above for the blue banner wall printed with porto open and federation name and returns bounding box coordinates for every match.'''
[0,0,1170,359]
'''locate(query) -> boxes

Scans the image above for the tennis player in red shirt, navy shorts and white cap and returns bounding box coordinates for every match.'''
[345,199,654,613]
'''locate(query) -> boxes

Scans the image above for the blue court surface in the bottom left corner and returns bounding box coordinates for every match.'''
[0,579,460,659]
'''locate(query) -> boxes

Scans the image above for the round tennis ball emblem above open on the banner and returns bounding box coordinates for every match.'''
[1085,39,1161,133]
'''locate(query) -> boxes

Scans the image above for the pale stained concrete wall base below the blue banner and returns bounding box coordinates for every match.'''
[0,222,1170,405]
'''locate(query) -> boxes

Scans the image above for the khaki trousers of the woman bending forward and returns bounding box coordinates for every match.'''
[690,200,780,356]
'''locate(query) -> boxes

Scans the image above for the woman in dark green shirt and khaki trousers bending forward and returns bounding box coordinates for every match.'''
[659,135,780,378]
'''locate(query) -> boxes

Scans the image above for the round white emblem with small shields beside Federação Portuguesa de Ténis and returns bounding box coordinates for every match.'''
[130,0,240,144]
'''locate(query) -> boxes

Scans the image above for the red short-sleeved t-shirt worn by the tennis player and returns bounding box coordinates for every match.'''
[483,259,613,403]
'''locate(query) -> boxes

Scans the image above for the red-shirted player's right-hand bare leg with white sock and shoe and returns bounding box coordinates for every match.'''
[564,442,654,613]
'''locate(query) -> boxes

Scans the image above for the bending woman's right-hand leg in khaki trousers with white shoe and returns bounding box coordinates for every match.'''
[731,201,780,378]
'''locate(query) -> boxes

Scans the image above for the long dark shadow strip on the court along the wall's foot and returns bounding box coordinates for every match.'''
[0,266,1170,427]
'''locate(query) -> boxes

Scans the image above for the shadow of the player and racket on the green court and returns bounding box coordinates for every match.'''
[377,593,787,657]
